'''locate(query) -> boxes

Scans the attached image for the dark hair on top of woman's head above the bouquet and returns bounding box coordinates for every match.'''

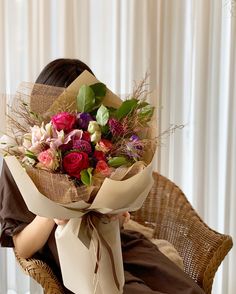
[36,58,93,88]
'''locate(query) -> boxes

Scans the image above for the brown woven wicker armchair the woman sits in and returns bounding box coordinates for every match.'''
[16,173,233,294]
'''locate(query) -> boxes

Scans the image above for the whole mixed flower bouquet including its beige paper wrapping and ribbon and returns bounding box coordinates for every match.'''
[1,71,156,294]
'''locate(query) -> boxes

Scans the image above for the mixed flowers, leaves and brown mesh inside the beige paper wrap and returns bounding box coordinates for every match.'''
[1,71,155,203]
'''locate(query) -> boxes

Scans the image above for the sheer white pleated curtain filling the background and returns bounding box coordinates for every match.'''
[0,0,236,294]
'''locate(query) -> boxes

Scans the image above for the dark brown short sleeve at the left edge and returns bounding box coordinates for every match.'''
[0,161,35,247]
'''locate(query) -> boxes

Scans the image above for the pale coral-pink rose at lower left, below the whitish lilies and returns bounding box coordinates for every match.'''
[37,149,59,170]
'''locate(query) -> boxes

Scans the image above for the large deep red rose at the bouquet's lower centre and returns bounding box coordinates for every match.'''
[62,151,89,179]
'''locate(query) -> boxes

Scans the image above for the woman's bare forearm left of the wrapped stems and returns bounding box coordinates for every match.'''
[13,216,55,258]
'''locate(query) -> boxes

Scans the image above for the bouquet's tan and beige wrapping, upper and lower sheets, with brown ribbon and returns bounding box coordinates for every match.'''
[5,71,155,294]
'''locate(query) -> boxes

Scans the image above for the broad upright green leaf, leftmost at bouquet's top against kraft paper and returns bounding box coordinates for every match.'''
[77,85,95,112]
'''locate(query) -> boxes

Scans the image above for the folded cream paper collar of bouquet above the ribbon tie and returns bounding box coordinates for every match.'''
[4,156,153,219]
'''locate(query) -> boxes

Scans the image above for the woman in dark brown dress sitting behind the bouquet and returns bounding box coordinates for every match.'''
[0,59,203,294]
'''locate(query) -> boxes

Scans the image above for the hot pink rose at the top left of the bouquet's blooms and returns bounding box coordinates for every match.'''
[51,112,76,133]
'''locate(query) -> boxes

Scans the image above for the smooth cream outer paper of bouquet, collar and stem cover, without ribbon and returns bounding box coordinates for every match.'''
[5,156,153,294]
